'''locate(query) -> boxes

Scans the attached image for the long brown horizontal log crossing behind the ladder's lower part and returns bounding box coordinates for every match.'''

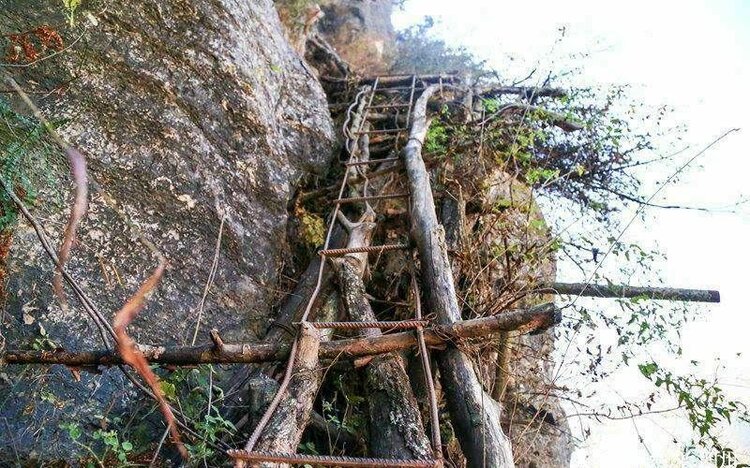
[0,303,562,367]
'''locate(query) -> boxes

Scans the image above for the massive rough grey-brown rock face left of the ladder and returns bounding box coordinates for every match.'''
[0,0,334,464]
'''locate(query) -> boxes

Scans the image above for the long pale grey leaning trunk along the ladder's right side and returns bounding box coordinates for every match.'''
[403,86,514,467]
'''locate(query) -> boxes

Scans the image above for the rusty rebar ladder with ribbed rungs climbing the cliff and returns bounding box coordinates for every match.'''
[227,75,442,468]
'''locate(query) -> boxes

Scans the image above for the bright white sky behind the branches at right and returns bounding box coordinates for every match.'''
[394,0,750,467]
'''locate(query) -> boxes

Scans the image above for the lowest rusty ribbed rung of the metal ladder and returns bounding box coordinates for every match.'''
[227,450,435,468]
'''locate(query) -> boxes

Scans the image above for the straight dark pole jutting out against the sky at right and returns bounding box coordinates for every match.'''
[536,283,721,302]
